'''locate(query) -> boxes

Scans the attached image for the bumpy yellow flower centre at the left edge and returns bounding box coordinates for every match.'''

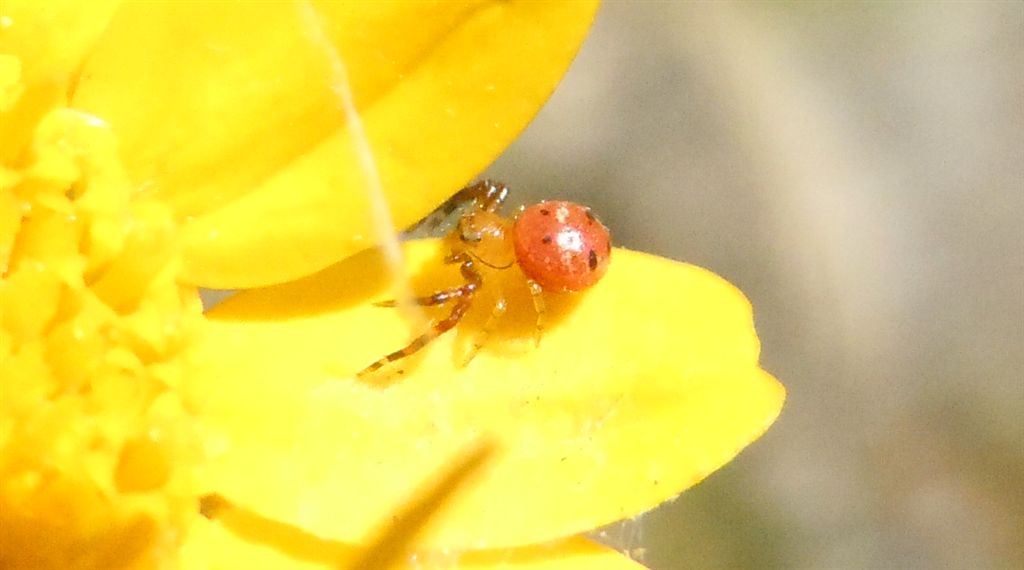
[0,78,203,570]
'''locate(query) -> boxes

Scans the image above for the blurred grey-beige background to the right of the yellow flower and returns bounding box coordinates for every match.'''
[488,2,1024,570]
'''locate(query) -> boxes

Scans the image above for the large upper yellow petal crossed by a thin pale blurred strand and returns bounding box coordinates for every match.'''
[74,1,596,288]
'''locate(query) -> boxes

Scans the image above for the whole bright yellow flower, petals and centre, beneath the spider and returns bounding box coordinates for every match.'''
[0,0,783,569]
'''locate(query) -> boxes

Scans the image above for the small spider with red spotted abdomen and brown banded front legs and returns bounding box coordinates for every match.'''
[357,180,611,377]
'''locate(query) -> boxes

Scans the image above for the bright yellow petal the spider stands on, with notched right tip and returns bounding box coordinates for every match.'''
[188,240,784,549]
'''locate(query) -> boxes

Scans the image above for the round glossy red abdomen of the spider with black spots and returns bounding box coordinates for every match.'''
[513,202,611,291]
